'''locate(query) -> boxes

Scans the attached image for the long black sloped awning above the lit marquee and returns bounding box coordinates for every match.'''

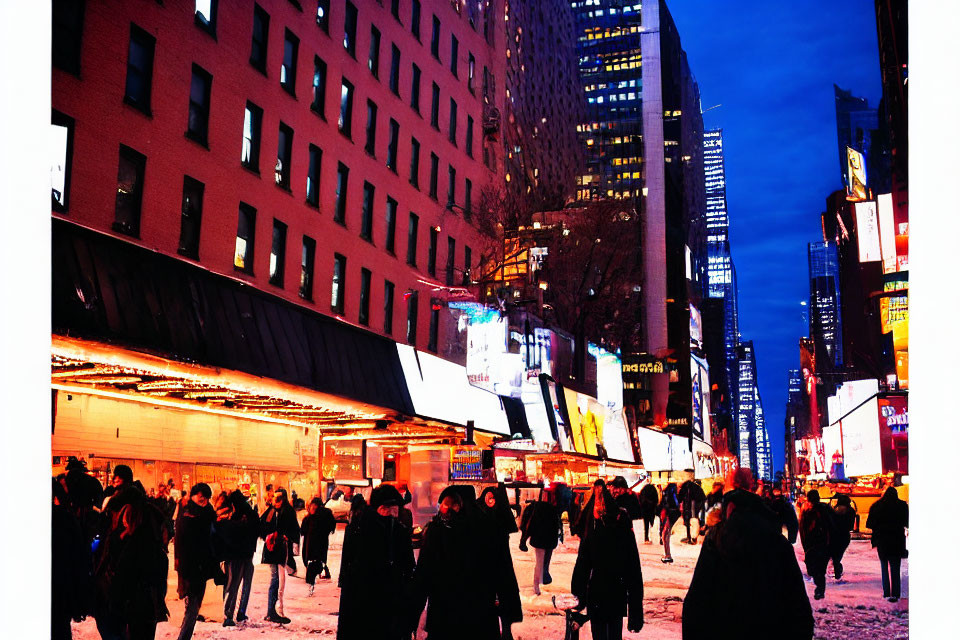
[51,218,414,415]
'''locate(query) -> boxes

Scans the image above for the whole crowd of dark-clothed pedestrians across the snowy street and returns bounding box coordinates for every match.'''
[51,460,908,640]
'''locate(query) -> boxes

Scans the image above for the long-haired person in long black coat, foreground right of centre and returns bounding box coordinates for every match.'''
[570,480,643,640]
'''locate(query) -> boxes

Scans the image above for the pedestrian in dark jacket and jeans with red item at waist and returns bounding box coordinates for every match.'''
[260,489,300,624]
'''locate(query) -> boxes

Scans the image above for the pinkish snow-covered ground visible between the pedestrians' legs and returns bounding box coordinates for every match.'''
[73,523,909,640]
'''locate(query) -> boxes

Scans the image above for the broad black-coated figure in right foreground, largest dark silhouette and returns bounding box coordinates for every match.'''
[683,489,814,640]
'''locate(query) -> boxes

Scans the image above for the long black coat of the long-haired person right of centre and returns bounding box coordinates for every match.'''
[570,509,643,628]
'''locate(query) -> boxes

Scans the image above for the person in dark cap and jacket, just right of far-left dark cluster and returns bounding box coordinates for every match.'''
[173,482,223,640]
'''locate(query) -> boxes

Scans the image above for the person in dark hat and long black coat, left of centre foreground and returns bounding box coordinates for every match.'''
[336,485,416,640]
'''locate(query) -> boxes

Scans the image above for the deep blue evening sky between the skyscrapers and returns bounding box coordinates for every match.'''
[668,0,881,469]
